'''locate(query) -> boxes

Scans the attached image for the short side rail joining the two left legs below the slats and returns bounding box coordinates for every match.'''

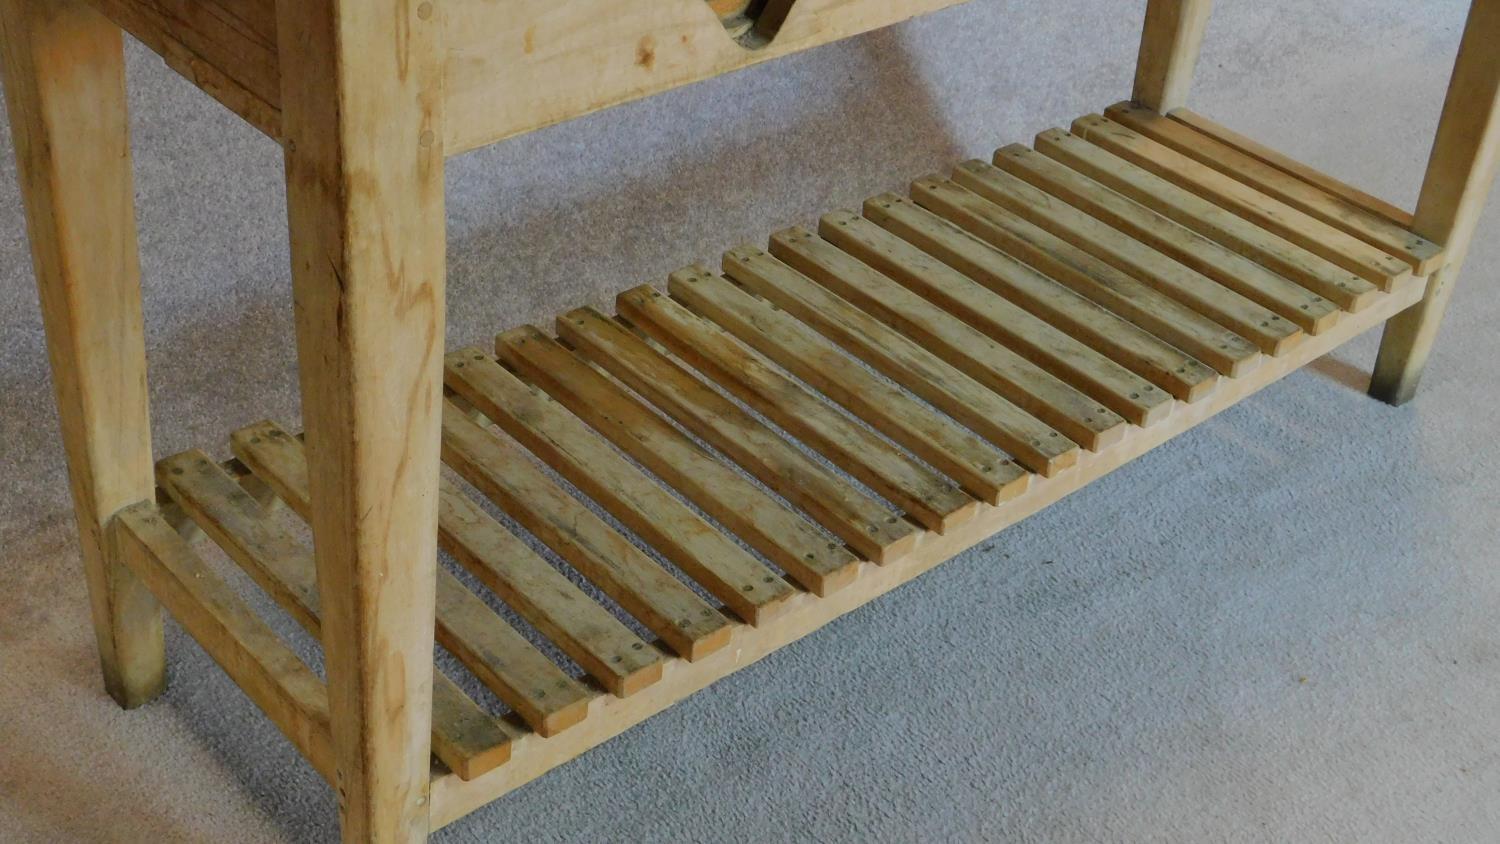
[111,502,335,783]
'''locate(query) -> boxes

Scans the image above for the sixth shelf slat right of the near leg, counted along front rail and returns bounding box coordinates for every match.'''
[495,325,860,595]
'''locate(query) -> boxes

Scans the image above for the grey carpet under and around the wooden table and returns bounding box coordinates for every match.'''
[0,0,1500,843]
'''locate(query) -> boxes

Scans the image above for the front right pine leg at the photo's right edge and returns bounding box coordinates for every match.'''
[1370,0,1500,405]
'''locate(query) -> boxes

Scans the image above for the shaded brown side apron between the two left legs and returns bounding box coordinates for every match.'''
[89,0,281,138]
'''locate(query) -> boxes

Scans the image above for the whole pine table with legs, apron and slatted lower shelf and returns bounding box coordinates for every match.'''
[0,0,1500,841]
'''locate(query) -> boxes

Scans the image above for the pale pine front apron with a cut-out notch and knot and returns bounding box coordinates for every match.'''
[446,0,962,153]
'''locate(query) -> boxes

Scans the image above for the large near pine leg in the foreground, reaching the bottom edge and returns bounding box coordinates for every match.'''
[276,0,447,843]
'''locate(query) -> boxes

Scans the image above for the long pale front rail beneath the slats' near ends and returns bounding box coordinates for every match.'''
[432,272,1424,826]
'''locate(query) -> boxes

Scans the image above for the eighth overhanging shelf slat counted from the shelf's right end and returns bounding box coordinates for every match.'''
[819,211,1217,410]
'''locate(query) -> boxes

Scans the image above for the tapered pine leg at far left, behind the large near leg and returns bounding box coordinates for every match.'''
[0,0,167,709]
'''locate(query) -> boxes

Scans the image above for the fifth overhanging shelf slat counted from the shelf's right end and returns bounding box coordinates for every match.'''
[953,155,1304,355]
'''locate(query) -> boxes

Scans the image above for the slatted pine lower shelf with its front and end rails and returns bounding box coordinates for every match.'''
[120,105,1442,825]
